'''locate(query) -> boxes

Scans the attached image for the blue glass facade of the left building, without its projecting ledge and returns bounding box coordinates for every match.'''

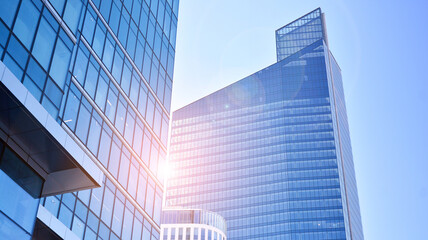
[0,0,179,240]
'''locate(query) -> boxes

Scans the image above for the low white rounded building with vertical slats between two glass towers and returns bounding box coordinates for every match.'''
[161,208,227,240]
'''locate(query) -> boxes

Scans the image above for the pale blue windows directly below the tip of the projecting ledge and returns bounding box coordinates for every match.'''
[42,177,161,240]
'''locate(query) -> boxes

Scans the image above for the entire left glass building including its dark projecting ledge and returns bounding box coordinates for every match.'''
[0,0,179,240]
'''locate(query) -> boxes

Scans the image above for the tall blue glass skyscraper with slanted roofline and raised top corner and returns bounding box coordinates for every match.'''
[166,9,363,240]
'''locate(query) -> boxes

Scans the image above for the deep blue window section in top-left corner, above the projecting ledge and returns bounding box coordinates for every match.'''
[0,0,74,118]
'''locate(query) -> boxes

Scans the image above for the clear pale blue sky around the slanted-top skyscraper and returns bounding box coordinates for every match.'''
[172,0,428,240]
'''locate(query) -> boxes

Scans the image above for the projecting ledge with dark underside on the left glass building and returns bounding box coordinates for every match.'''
[0,61,104,196]
